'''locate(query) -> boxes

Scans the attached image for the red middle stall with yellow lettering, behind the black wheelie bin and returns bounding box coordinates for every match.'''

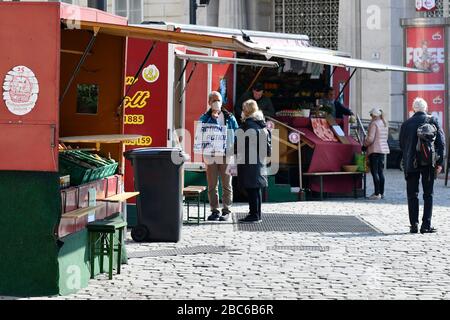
[125,30,278,218]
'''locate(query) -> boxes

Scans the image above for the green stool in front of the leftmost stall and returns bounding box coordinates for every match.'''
[87,218,127,280]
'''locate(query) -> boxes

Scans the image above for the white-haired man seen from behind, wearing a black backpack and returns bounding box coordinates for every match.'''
[400,98,445,234]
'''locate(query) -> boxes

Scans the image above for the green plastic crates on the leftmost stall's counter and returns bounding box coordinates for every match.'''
[59,150,119,186]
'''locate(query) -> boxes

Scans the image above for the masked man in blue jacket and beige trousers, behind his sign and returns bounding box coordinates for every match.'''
[200,91,239,221]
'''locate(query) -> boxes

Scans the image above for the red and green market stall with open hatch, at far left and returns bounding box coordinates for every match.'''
[0,2,268,296]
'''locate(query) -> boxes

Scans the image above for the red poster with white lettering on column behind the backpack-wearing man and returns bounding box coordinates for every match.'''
[406,27,446,128]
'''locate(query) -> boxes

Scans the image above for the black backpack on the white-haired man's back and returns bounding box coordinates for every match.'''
[416,117,438,167]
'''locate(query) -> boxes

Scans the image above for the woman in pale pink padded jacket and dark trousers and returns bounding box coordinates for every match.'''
[364,108,390,200]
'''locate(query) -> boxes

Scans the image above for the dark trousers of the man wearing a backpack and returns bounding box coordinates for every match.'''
[406,167,435,229]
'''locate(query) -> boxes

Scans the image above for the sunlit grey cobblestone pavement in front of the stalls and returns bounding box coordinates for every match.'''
[3,170,450,300]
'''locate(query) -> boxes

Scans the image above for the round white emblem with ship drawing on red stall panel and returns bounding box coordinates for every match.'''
[3,66,39,116]
